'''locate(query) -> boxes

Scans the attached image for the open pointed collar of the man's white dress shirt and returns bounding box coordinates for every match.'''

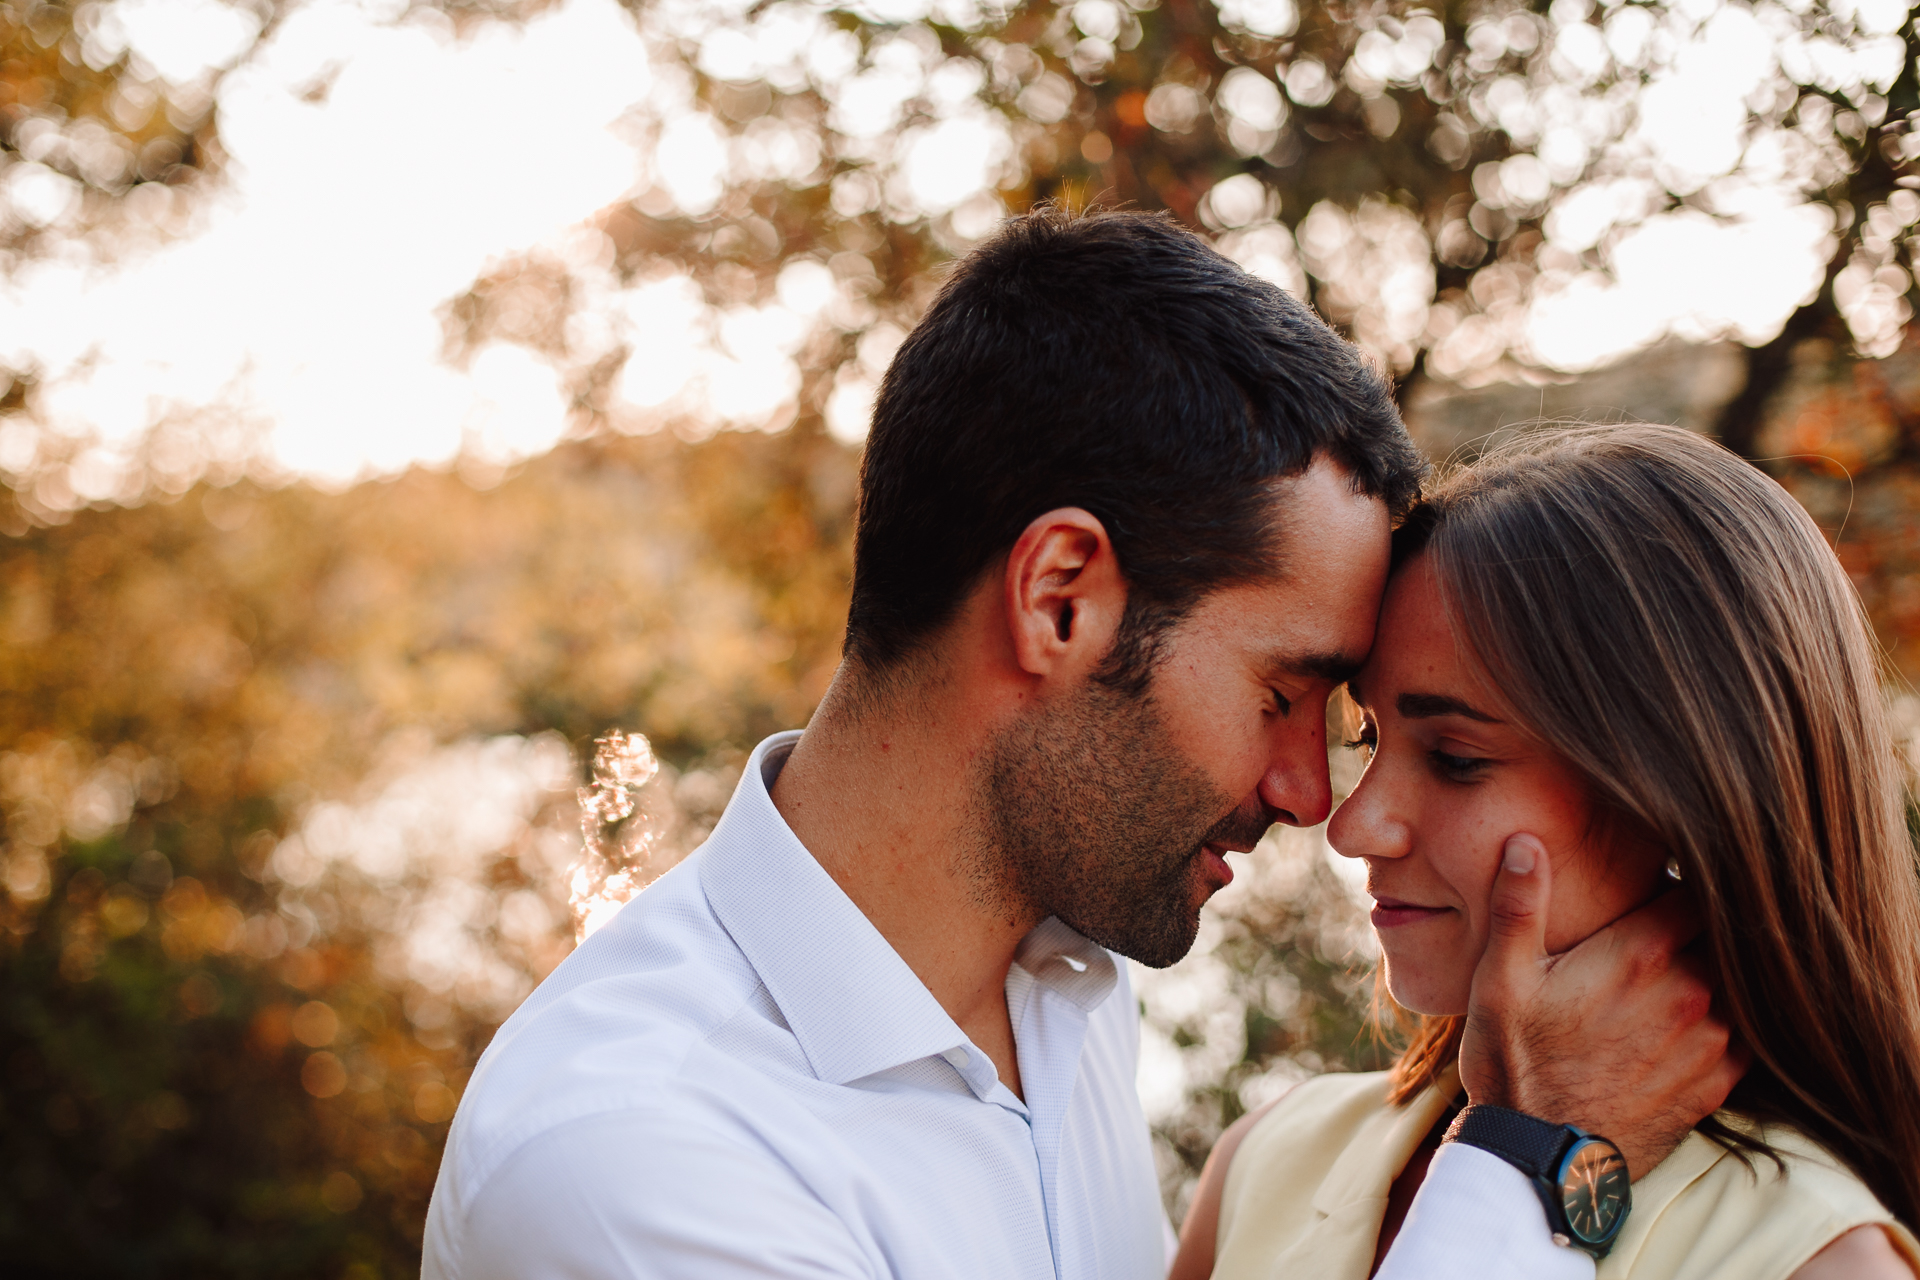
[699,729,1119,1084]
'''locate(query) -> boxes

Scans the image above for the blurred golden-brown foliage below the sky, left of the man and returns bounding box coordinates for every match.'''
[0,434,854,1276]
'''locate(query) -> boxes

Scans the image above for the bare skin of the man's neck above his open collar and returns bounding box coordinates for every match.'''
[772,668,1039,1094]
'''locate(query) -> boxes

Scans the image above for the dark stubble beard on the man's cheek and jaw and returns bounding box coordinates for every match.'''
[970,681,1267,969]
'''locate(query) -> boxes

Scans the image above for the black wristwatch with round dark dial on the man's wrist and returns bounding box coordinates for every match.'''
[1442,1105,1634,1257]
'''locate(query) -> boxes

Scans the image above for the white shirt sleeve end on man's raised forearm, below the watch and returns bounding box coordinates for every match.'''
[1377,1142,1596,1280]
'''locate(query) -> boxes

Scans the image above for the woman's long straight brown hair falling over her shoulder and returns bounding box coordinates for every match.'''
[1394,426,1920,1224]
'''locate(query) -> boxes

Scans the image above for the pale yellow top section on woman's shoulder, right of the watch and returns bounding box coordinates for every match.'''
[1599,1115,1920,1280]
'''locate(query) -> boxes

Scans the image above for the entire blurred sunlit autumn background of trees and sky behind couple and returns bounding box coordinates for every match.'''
[0,0,1920,1276]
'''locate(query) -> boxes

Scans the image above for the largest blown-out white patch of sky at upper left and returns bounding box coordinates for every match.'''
[0,0,649,482]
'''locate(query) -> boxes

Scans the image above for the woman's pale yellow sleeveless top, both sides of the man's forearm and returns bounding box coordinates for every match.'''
[1213,1071,1920,1280]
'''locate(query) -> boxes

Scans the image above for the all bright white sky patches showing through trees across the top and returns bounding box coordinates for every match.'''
[0,0,1899,499]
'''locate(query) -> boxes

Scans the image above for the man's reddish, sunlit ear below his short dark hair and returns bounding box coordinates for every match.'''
[1006,507,1127,676]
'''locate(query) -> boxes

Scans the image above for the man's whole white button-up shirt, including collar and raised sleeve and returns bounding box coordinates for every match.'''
[422,733,1594,1280]
